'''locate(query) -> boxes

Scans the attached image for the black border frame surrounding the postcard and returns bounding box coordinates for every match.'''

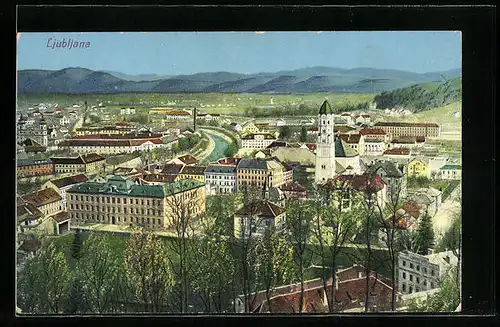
[0,1,498,325]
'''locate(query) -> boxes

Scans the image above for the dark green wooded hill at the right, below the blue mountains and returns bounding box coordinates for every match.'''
[374,77,462,112]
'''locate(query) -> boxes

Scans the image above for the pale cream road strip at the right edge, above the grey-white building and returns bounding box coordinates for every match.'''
[432,184,462,243]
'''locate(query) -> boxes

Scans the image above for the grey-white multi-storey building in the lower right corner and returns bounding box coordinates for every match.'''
[397,251,458,294]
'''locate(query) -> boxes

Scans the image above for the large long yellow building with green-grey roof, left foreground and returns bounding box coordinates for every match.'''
[67,176,205,228]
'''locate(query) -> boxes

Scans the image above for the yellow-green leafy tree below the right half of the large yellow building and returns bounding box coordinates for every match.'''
[124,230,174,312]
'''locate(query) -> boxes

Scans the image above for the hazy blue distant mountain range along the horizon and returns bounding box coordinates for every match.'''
[18,67,461,94]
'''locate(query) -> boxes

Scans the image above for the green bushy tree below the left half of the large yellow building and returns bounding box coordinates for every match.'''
[76,233,119,313]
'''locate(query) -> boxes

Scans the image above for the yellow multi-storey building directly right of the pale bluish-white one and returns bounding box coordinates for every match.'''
[236,158,285,189]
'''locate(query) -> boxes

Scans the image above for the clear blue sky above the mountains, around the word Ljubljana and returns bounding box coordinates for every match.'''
[17,31,462,75]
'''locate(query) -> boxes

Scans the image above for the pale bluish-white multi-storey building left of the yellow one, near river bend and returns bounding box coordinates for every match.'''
[205,164,237,194]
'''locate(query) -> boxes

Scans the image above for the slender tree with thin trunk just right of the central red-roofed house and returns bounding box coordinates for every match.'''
[286,200,313,312]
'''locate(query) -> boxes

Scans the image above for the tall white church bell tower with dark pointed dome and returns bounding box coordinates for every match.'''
[314,100,336,183]
